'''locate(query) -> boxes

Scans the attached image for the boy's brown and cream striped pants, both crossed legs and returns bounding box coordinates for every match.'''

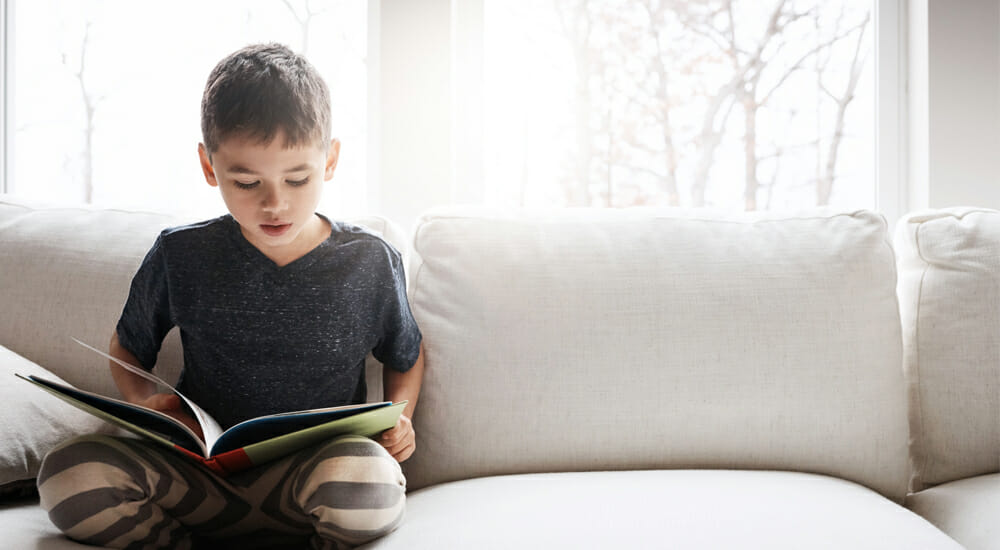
[38,435,406,549]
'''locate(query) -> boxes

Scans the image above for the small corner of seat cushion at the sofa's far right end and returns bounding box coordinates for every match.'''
[906,474,1000,550]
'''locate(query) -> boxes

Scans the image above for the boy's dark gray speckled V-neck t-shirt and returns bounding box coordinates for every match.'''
[117,215,421,429]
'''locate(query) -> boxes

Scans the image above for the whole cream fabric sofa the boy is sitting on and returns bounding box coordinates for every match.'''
[0,197,1000,550]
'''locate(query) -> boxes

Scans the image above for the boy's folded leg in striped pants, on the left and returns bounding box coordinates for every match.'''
[38,435,250,548]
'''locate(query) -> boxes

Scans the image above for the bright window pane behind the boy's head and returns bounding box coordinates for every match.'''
[8,0,367,220]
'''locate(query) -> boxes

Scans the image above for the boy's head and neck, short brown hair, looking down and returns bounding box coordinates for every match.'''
[198,44,340,265]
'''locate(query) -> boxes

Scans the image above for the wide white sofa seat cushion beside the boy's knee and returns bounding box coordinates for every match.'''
[366,470,961,550]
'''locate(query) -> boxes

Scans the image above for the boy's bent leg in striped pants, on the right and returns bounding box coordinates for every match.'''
[249,435,406,548]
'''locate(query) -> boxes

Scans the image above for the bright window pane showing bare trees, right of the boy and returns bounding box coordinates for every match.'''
[483,0,875,210]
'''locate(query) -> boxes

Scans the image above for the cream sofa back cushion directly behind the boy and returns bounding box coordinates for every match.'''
[0,196,408,406]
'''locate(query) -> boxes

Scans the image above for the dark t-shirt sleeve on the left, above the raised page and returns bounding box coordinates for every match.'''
[116,234,174,370]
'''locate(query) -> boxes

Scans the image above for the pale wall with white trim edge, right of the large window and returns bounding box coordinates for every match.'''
[908,0,1000,210]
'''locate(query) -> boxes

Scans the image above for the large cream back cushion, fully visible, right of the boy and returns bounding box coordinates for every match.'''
[403,209,907,501]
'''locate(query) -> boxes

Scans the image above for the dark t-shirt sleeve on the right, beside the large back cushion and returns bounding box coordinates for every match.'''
[372,245,421,372]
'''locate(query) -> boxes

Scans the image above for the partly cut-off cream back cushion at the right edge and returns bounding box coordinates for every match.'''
[895,208,1000,491]
